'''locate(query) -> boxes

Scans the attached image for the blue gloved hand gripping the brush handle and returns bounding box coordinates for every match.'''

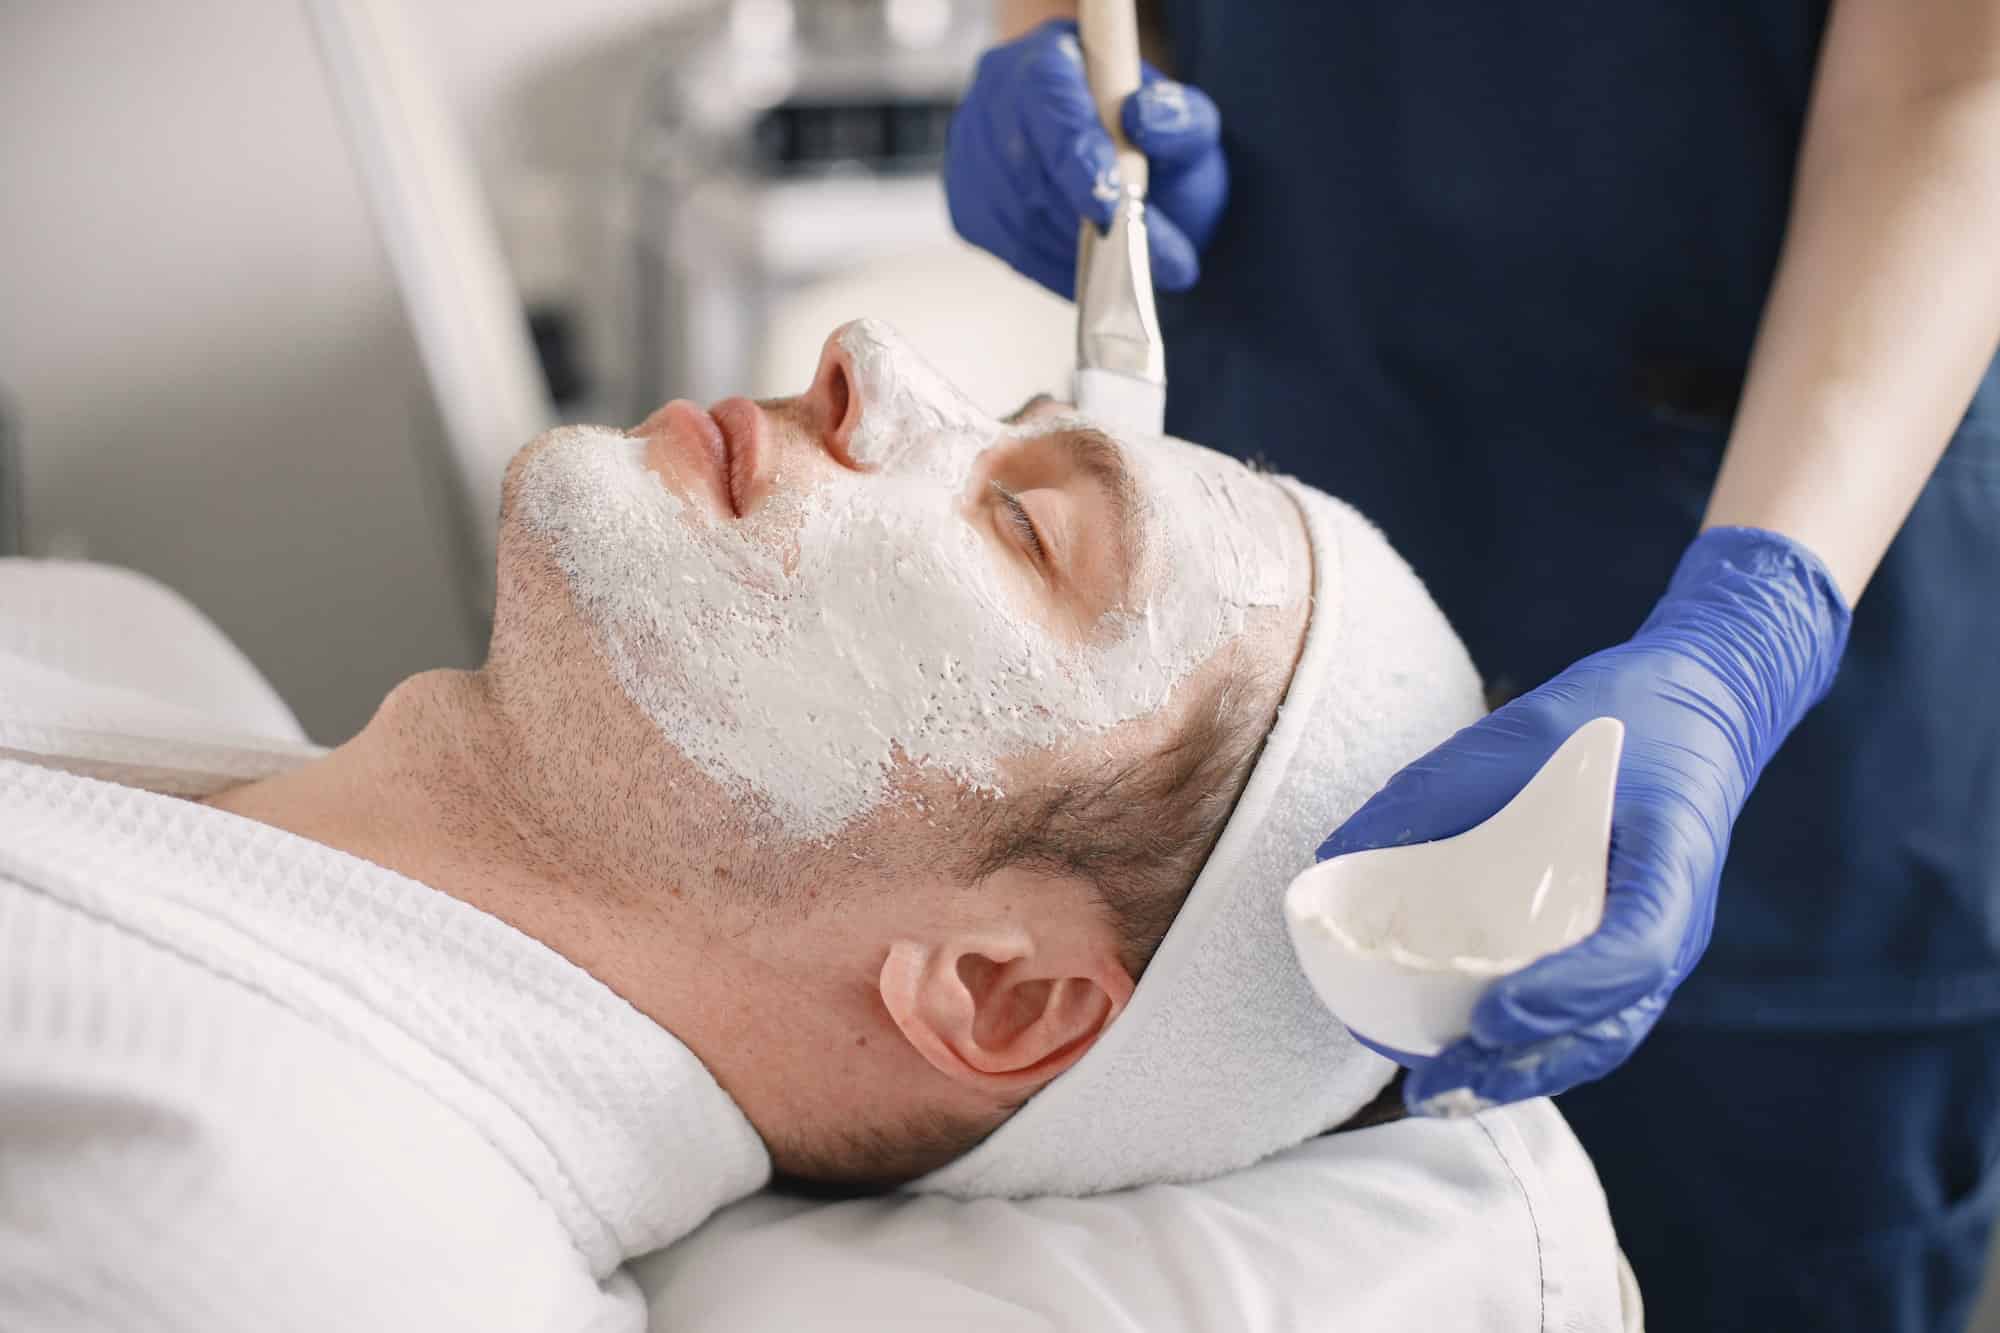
[944,20,1230,296]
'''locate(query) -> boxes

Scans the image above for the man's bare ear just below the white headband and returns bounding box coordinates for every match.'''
[880,880,1132,1095]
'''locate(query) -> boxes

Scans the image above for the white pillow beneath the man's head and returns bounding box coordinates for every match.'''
[632,1101,1638,1333]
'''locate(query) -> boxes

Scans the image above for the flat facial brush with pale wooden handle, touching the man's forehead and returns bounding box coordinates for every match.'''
[1076,0,1166,434]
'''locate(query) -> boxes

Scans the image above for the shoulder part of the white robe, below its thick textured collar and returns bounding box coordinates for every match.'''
[0,877,638,1329]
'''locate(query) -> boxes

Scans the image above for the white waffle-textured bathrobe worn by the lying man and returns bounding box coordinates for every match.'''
[0,562,770,1331]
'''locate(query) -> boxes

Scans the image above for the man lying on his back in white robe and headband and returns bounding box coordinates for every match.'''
[0,322,1610,1329]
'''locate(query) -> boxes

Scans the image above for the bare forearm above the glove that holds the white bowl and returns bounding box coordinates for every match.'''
[1704,0,2000,604]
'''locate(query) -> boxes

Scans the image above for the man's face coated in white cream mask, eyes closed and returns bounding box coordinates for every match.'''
[496,320,1308,845]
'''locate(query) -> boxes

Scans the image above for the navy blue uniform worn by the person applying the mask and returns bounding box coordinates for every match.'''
[1162,0,2000,1333]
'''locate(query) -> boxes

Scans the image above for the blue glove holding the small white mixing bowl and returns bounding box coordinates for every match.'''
[1320,528,1848,1115]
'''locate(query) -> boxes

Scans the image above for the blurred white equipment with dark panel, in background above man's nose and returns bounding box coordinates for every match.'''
[626,0,990,416]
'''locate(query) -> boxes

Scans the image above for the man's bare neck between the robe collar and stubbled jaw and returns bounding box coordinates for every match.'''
[206,671,948,1160]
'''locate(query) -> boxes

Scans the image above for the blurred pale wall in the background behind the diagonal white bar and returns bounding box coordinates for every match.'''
[0,0,672,741]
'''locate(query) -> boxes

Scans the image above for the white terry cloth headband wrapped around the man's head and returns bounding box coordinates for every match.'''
[910,478,1486,1199]
